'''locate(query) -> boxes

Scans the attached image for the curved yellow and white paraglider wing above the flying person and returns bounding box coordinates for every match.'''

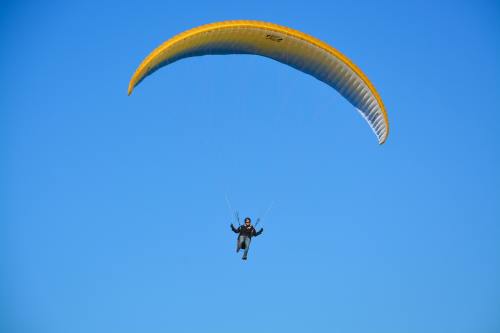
[128,21,389,144]
